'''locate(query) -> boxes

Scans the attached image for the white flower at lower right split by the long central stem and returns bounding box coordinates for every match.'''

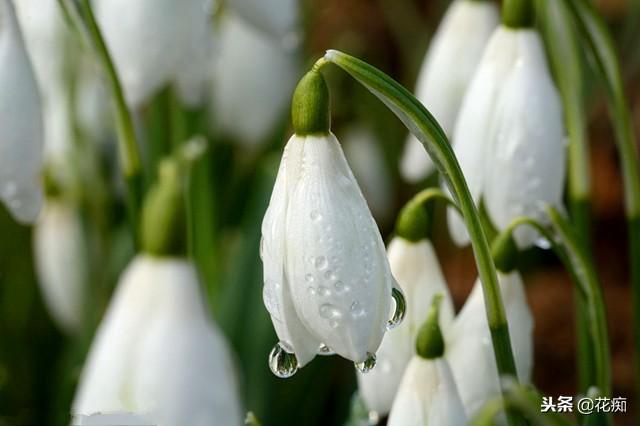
[446,272,533,417]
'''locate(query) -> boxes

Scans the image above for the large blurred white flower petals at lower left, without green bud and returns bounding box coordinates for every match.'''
[72,255,242,426]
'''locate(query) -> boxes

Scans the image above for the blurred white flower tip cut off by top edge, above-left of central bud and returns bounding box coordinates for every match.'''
[229,0,300,47]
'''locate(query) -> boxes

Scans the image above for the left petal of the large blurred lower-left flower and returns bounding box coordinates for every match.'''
[72,256,160,415]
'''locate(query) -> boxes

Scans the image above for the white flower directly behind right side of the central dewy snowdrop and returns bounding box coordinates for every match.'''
[358,237,453,418]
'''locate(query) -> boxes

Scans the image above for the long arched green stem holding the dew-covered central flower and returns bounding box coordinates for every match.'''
[317,50,520,424]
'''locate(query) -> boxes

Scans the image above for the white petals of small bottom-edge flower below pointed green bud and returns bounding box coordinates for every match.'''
[387,356,468,426]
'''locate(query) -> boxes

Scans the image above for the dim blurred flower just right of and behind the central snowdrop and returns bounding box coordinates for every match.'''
[341,127,394,223]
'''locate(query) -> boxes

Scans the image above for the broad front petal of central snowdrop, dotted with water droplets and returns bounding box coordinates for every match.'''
[285,135,393,362]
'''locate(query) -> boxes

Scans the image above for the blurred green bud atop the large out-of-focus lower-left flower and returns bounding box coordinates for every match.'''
[141,159,187,256]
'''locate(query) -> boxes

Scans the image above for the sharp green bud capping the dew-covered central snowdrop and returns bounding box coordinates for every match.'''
[291,70,331,136]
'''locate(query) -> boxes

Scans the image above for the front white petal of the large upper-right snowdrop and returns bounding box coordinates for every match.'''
[484,30,566,248]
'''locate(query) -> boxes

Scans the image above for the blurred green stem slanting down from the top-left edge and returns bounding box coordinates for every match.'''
[82,0,142,241]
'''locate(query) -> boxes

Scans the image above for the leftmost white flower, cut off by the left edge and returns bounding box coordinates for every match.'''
[0,0,43,222]
